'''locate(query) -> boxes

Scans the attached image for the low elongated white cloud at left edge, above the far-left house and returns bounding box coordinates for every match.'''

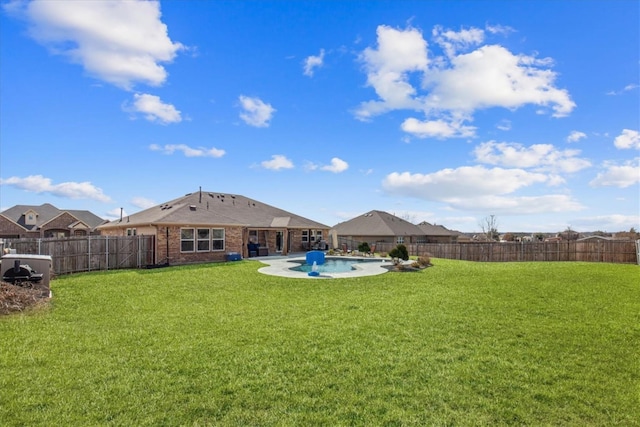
[0,175,111,202]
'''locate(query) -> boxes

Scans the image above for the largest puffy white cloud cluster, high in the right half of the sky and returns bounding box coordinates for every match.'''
[355,25,575,137]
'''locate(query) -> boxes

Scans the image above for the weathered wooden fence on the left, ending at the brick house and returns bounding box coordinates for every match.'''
[4,236,155,274]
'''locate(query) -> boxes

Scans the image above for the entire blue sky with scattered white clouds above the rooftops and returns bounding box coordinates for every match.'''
[0,0,640,232]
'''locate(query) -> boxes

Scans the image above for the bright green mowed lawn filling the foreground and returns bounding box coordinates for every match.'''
[0,259,640,426]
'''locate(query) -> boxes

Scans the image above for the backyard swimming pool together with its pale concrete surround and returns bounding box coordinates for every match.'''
[258,256,390,279]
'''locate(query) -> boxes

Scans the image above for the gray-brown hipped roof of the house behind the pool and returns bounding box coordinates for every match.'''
[333,211,425,236]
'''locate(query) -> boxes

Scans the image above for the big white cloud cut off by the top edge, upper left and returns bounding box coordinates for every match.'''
[7,0,183,90]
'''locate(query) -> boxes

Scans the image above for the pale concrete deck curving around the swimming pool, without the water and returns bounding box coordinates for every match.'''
[251,254,391,279]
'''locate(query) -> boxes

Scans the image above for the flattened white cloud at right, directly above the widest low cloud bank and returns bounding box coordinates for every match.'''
[474,141,591,173]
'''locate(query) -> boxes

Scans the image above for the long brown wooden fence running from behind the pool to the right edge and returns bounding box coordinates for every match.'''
[341,239,640,264]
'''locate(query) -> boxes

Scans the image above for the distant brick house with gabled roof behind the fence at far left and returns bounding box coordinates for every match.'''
[0,203,105,239]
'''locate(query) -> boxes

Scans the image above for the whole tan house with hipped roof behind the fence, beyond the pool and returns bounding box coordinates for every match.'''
[331,211,427,249]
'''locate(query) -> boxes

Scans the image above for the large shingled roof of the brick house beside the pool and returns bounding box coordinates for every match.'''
[100,191,329,229]
